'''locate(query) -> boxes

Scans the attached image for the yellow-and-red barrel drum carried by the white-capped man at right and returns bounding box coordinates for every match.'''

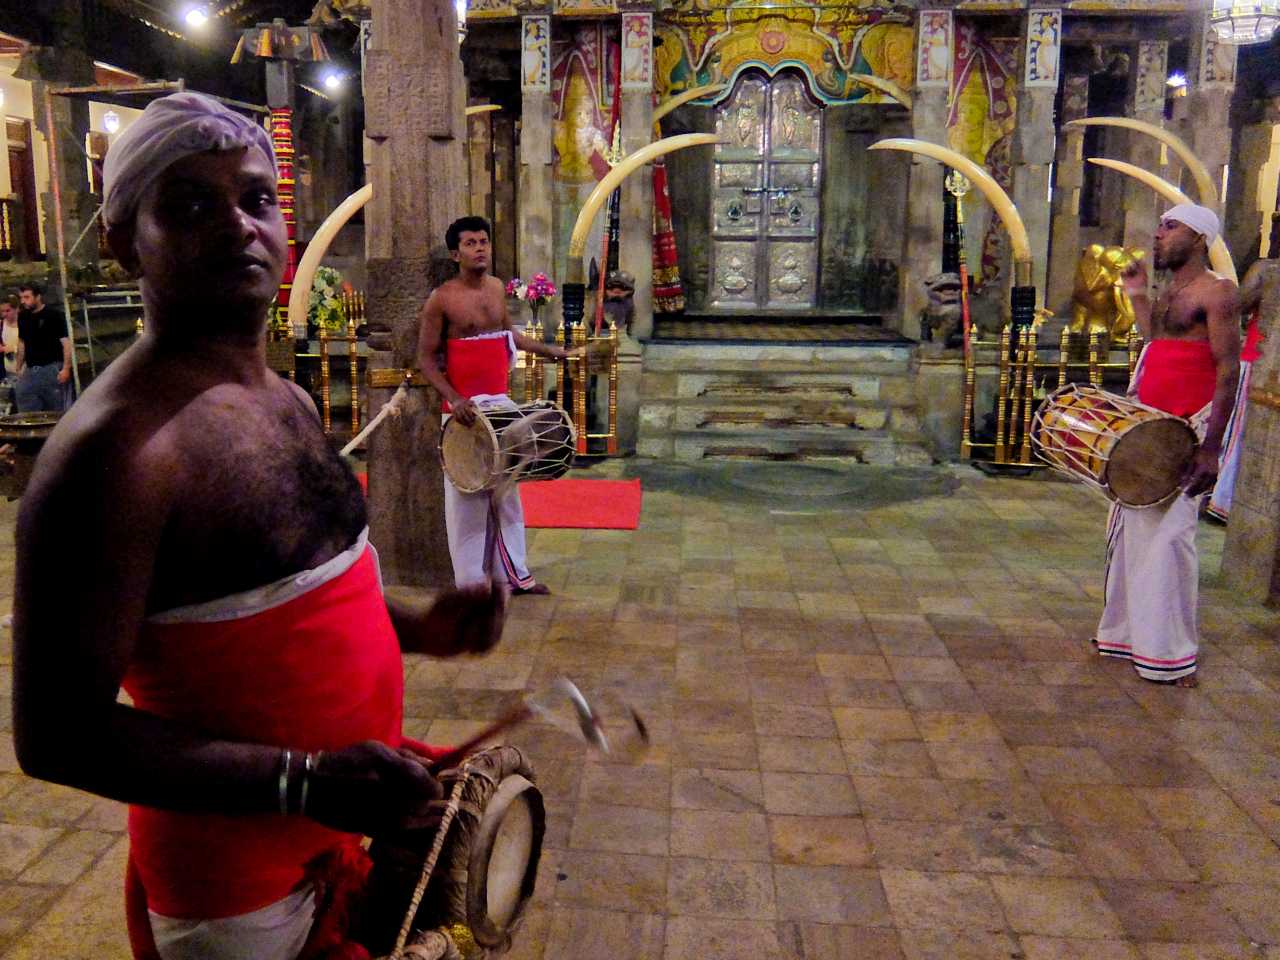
[1032,384,1199,507]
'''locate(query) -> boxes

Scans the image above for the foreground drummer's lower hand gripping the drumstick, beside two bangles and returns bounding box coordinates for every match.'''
[302,740,444,836]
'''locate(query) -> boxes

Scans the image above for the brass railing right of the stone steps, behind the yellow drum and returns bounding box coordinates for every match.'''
[960,325,1142,466]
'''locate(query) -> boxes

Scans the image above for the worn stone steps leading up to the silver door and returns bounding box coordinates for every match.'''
[637,343,933,466]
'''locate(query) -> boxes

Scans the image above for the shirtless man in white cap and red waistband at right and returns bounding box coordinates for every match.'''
[1096,204,1240,686]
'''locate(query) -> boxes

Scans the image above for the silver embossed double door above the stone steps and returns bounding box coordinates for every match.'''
[709,73,822,311]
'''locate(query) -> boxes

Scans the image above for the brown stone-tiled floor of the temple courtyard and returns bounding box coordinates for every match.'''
[0,462,1280,960]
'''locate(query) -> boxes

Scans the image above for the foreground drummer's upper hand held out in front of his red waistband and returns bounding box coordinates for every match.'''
[387,581,507,657]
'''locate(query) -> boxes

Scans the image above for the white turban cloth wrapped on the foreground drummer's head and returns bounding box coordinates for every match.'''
[102,92,279,227]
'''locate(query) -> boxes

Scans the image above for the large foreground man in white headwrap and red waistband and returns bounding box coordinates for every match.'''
[13,93,504,960]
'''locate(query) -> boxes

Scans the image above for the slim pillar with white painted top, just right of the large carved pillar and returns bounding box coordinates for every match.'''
[516,17,550,300]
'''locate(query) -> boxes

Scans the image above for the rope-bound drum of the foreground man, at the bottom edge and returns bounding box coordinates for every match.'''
[360,746,547,957]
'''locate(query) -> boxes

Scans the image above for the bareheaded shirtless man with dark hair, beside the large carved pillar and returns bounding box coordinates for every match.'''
[417,216,568,594]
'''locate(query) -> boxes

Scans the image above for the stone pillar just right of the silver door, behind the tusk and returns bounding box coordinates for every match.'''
[893,9,955,337]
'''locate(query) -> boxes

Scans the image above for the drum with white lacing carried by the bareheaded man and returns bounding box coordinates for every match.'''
[440,401,577,493]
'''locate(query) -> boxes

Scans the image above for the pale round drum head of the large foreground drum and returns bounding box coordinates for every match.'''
[467,774,547,950]
